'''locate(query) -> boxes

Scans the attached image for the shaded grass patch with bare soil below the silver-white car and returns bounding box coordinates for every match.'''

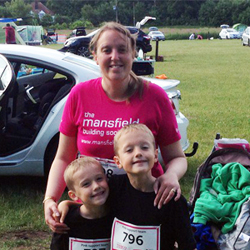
[0,177,66,250]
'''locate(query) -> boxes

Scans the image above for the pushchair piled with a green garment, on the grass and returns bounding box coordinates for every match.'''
[189,134,250,250]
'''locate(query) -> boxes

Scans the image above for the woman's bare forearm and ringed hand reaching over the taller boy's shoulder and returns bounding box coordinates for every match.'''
[154,141,187,208]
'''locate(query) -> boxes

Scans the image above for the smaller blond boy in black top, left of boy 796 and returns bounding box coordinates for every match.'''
[51,157,113,250]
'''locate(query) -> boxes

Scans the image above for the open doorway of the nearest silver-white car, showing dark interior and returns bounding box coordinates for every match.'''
[0,56,71,156]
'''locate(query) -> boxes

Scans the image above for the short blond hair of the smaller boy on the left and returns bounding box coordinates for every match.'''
[64,156,102,191]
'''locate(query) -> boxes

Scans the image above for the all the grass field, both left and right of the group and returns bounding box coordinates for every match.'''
[0,39,250,250]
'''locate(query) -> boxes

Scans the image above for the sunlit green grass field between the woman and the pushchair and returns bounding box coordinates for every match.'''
[149,39,250,195]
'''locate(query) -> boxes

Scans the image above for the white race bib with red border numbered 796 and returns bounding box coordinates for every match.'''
[111,218,160,250]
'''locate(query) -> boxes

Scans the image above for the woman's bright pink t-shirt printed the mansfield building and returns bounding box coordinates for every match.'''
[60,78,181,177]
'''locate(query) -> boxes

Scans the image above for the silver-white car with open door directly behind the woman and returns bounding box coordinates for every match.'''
[0,44,196,176]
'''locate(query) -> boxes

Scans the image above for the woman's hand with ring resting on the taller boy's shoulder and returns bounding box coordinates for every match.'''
[154,173,181,209]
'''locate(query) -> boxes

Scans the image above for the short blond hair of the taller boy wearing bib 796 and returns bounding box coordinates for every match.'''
[114,123,156,155]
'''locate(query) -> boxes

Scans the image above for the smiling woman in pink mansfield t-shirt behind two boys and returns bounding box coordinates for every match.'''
[44,22,187,232]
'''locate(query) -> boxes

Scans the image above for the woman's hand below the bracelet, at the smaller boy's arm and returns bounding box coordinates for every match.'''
[44,199,69,234]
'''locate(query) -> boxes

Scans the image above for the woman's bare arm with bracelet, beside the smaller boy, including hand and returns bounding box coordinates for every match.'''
[44,133,77,232]
